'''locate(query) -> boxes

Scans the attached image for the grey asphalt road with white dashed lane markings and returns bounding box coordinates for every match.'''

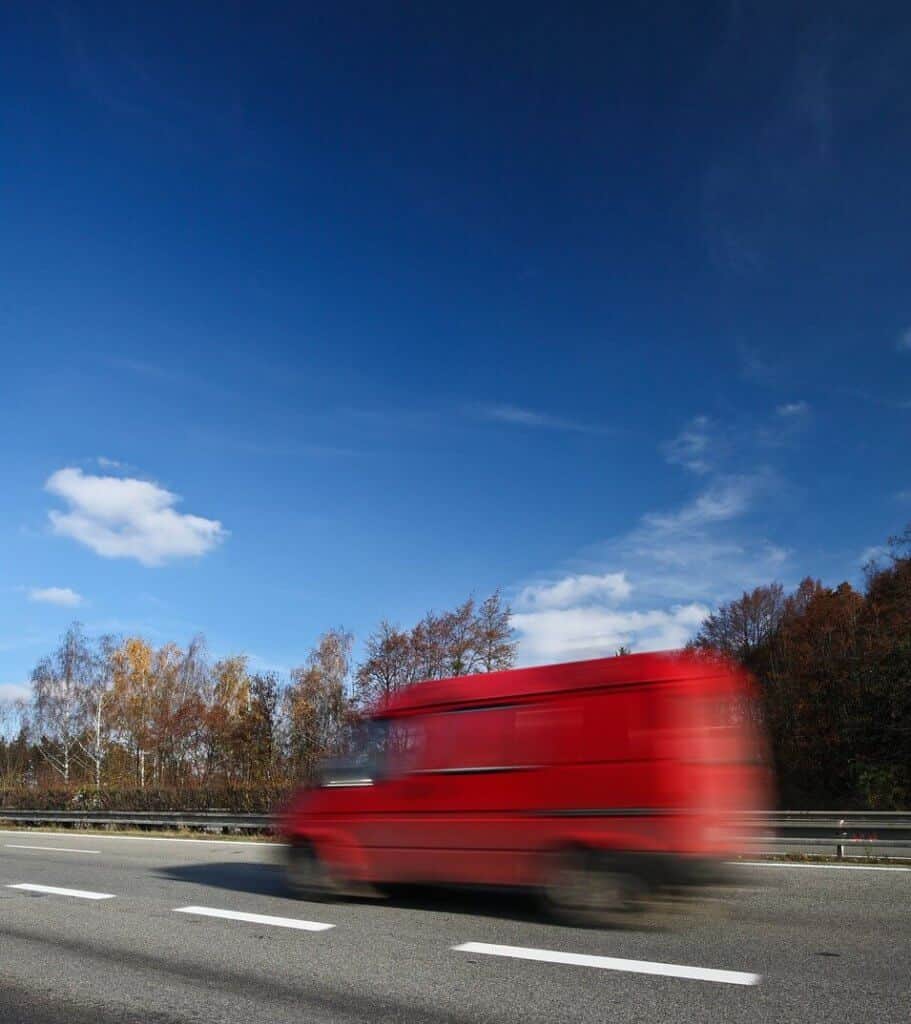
[0,830,911,1024]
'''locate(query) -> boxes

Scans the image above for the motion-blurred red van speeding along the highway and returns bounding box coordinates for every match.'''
[277,654,768,919]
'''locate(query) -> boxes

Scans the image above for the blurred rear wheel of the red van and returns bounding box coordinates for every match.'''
[544,850,645,928]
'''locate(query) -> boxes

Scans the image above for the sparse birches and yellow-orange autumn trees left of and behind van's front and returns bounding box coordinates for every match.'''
[0,591,516,805]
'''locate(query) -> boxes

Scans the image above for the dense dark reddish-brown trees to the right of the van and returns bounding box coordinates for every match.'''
[694,526,911,810]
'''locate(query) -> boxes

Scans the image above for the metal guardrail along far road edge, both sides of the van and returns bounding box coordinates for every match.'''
[0,808,911,859]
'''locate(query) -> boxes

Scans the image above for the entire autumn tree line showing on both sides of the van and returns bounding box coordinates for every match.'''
[0,527,911,810]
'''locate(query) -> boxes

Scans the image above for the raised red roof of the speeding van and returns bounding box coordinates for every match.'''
[375,651,733,716]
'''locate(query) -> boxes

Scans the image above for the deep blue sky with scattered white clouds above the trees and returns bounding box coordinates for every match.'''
[0,3,911,695]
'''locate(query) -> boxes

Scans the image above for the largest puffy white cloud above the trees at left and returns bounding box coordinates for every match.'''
[45,467,227,566]
